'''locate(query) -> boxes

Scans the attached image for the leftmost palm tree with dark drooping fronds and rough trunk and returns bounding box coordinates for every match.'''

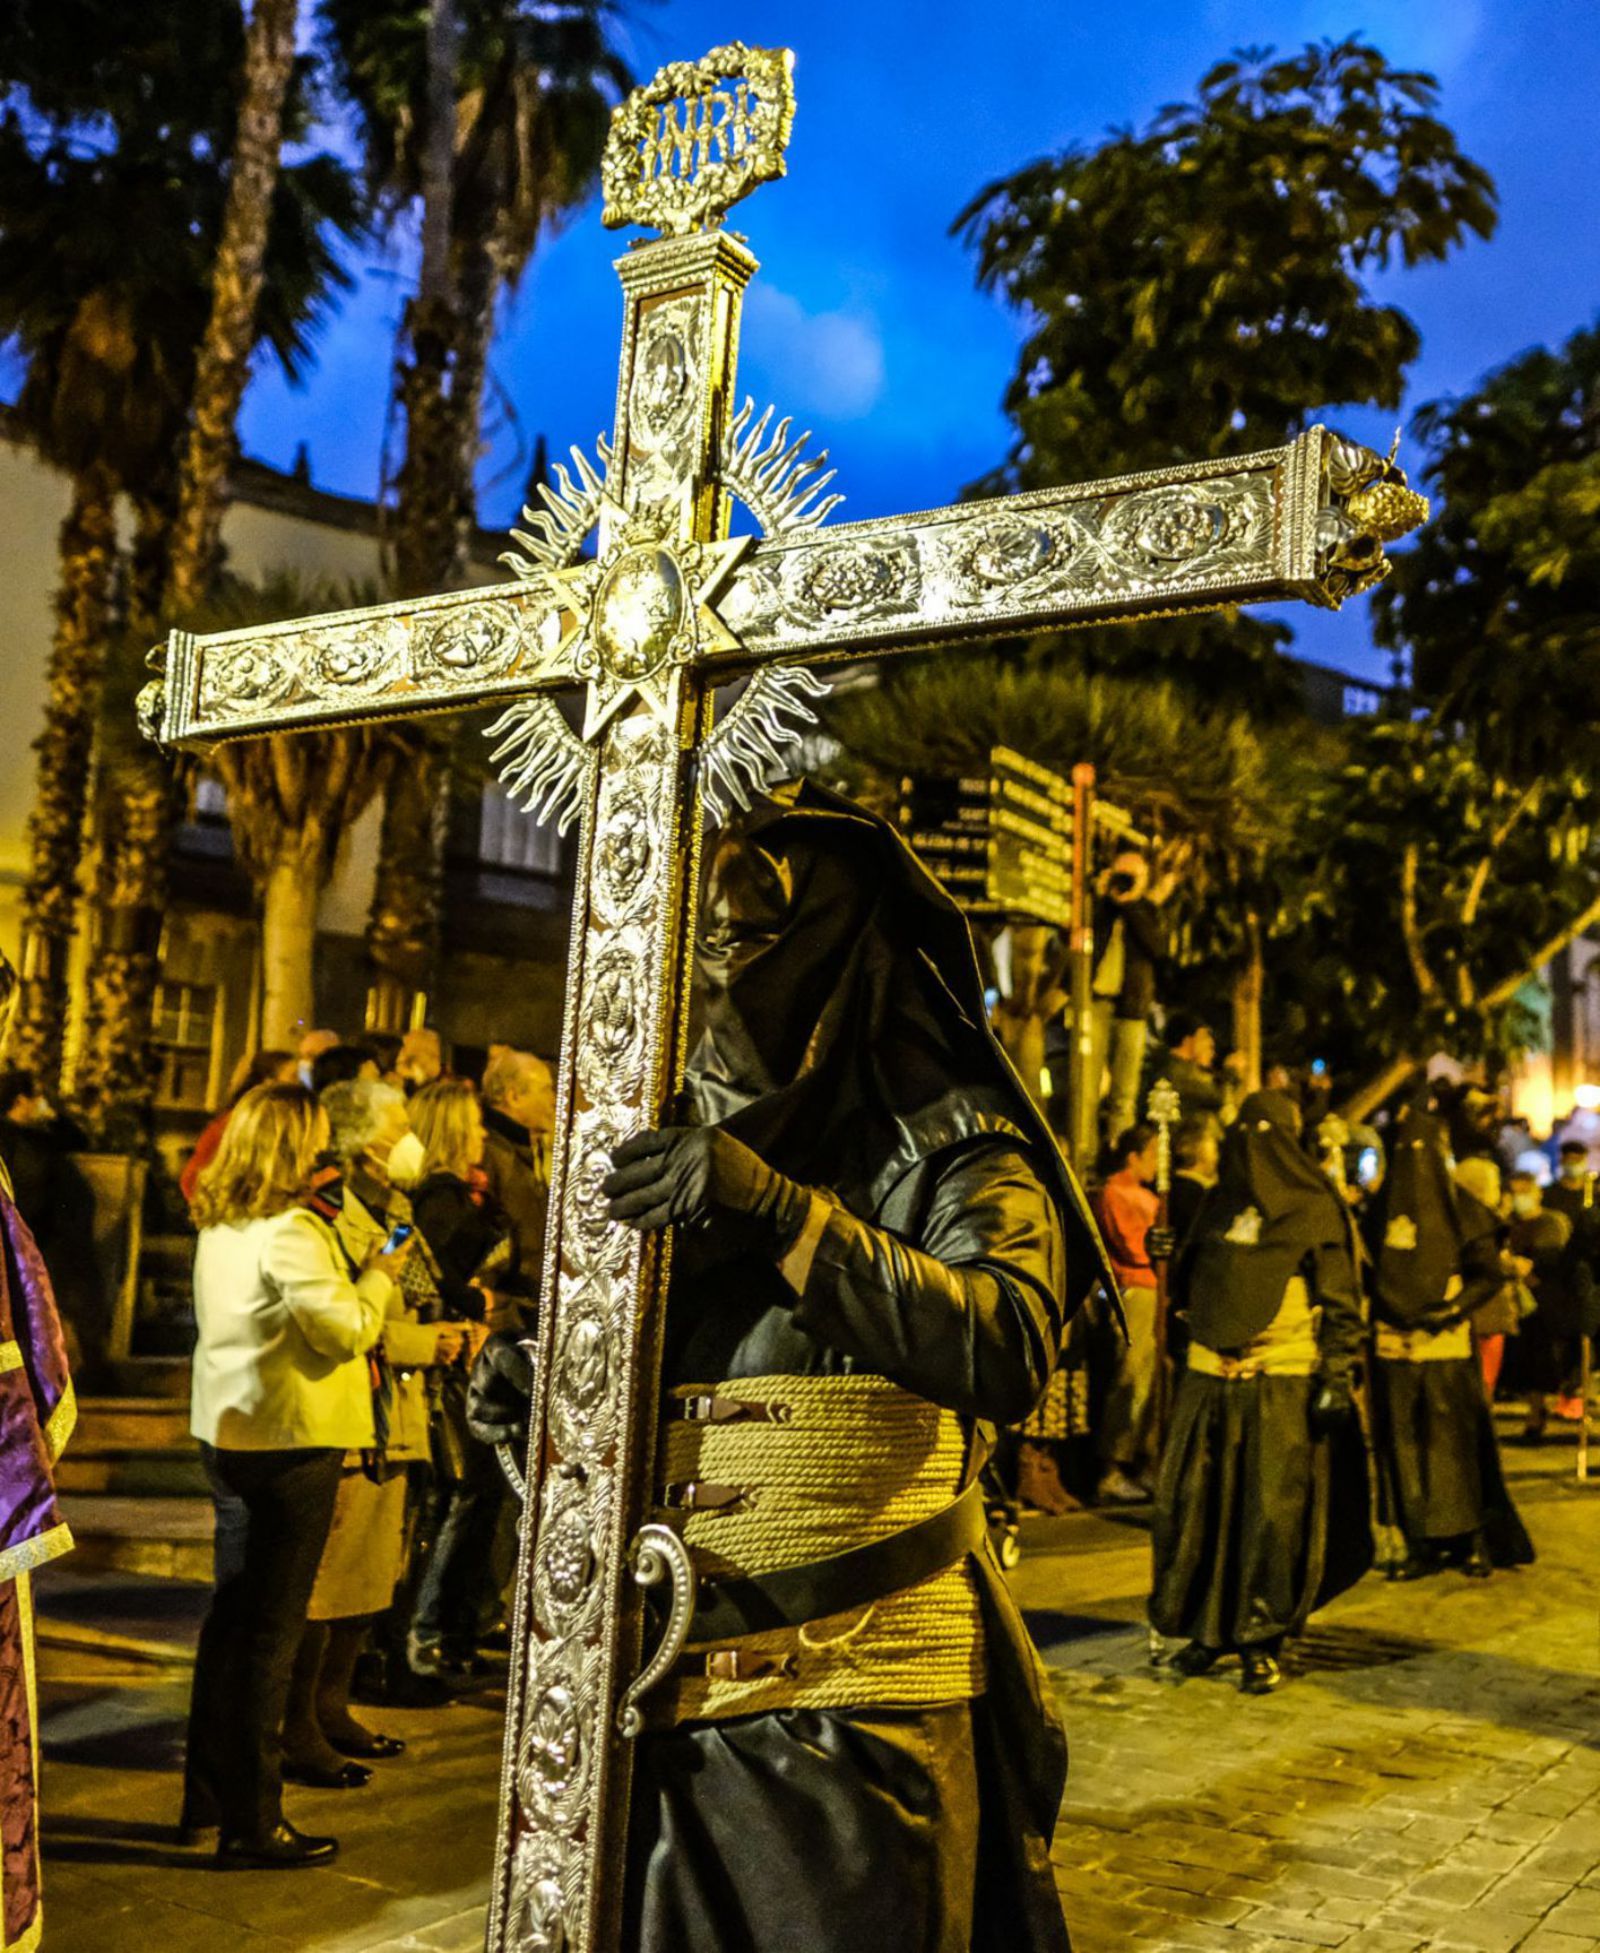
[0,0,358,1117]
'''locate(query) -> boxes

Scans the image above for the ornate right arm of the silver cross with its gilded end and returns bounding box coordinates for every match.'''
[719,428,1428,664]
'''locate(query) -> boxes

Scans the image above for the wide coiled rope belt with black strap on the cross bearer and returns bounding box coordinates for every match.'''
[653,1375,985,1721]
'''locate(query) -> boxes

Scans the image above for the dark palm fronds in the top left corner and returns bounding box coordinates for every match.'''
[0,0,361,490]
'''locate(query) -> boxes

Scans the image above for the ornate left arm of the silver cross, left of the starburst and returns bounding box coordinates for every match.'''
[141,582,576,746]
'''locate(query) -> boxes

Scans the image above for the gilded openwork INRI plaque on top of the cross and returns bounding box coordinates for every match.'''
[600,41,795,236]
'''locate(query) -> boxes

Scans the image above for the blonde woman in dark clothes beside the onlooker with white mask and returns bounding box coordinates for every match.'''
[406,1078,514,1683]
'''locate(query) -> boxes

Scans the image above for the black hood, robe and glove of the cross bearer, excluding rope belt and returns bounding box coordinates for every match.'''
[468,785,1106,1953]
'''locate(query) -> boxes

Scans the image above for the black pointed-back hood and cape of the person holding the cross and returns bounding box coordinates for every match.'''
[688,781,1110,1312]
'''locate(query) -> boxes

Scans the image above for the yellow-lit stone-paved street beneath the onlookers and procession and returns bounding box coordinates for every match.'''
[41,1421,1600,1953]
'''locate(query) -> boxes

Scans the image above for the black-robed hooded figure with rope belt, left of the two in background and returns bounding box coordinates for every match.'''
[1151,1092,1371,1693]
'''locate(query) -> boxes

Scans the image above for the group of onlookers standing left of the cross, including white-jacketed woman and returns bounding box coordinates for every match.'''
[182,1029,555,1865]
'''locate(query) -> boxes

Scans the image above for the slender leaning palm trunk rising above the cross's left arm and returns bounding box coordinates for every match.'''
[168,0,299,617]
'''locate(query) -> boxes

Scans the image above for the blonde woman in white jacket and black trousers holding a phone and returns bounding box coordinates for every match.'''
[182,1084,404,1865]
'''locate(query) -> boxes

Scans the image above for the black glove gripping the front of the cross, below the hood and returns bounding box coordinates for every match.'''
[606,1125,811,1260]
